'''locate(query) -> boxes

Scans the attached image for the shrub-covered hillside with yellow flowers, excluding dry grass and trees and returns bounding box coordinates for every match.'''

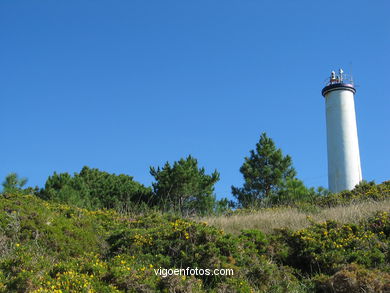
[0,182,390,292]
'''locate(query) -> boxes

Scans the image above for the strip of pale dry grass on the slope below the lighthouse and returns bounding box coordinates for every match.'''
[200,200,390,234]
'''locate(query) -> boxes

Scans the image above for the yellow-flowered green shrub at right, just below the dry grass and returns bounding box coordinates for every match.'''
[280,216,388,274]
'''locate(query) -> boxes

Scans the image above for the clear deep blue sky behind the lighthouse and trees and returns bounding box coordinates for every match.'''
[0,0,390,197]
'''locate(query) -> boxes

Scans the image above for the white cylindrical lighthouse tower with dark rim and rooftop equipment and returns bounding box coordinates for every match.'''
[322,69,362,192]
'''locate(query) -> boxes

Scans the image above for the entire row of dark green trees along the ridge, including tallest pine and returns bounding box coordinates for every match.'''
[3,133,327,215]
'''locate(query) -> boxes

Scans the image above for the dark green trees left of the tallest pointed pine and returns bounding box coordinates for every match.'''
[3,156,229,215]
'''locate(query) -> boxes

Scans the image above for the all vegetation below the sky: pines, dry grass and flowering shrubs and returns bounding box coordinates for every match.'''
[0,133,390,293]
